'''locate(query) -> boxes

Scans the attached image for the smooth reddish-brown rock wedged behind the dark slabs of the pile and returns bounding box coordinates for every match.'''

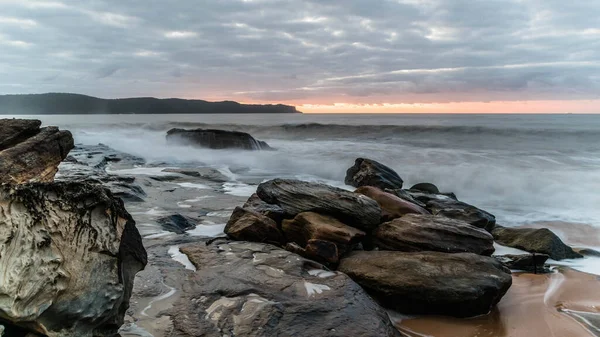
[354,186,431,221]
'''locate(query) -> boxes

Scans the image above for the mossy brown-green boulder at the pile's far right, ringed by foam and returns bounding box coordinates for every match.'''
[492,226,583,261]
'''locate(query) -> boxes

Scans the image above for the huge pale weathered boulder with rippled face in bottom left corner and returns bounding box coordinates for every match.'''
[0,182,147,337]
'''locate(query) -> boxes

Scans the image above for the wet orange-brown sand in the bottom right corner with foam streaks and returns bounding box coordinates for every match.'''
[396,268,600,337]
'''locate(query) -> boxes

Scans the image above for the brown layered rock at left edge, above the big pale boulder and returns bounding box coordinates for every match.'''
[0,119,74,184]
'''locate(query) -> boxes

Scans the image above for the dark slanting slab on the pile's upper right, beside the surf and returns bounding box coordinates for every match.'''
[407,190,496,232]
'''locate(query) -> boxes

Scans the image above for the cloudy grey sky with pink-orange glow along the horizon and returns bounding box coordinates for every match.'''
[0,0,600,113]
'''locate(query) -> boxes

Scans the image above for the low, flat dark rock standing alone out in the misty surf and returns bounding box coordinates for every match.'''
[167,129,272,150]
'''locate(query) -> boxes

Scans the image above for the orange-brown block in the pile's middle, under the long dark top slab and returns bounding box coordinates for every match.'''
[282,212,365,255]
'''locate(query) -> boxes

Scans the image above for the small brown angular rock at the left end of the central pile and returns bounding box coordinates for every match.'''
[225,207,284,245]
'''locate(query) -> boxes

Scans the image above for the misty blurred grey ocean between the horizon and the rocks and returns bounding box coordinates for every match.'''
[20,114,600,228]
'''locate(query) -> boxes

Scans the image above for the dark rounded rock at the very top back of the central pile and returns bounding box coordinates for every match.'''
[344,158,403,190]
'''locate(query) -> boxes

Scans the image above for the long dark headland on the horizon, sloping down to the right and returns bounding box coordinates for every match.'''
[0,93,299,115]
